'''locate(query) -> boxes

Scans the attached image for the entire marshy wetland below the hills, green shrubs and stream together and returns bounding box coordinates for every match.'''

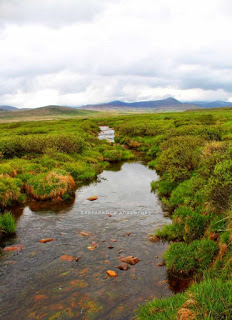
[0,109,232,319]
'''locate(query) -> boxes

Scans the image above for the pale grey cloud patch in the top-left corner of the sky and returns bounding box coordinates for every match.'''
[0,0,112,27]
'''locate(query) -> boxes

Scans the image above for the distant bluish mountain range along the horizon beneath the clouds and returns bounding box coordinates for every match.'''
[0,98,232,113]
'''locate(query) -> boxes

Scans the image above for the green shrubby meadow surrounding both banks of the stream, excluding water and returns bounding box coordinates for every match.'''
[0,108,232,320]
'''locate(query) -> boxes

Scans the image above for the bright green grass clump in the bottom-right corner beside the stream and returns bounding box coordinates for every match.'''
[136,279,232,320]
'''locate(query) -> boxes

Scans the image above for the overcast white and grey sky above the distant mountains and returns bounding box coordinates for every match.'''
[0,0,232,107]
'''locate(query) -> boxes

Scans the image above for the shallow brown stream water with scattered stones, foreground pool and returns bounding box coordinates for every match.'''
[0,127,185,320]
